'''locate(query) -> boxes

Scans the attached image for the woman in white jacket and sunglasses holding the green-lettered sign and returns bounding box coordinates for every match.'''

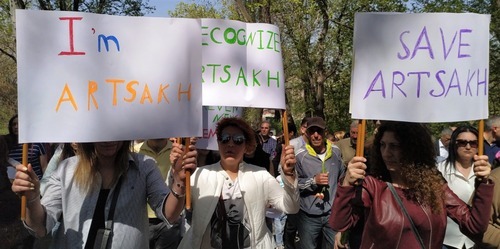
[174,118,299,249]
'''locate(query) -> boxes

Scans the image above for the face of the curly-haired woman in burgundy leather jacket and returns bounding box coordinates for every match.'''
[380,131,402,172]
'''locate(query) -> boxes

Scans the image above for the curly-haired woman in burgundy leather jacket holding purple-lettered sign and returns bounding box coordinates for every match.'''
[330,121,494,249]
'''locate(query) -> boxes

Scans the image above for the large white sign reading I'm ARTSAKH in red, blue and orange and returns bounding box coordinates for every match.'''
[16,10,202,142]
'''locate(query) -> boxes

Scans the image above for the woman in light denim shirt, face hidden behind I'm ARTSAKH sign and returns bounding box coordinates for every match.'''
[12,141,196,249]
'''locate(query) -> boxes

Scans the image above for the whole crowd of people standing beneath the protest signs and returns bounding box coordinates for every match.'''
[0,113,500,249]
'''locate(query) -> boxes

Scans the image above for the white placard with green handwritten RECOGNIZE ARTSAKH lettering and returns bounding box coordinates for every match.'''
[202,19,285,109]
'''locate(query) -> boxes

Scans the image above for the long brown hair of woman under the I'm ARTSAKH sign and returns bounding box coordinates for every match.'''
[75,141,130,193]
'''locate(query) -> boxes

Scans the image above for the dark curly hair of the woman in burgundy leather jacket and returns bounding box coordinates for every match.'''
[369,121,445,214]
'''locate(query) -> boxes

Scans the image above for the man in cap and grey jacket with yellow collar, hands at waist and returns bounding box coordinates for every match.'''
[296,117,344,249]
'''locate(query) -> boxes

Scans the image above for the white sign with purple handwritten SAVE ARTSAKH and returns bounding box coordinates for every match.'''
[351,13,490,122]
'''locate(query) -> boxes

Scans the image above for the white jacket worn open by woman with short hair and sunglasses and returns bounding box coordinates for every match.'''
[175,162,299,249]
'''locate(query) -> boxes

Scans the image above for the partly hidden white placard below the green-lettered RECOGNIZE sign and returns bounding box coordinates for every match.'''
[196,106,243,150]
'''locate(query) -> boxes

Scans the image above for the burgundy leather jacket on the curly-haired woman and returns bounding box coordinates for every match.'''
[329,176,494,249]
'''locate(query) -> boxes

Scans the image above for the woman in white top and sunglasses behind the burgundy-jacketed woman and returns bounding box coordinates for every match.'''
[438,125,478,249]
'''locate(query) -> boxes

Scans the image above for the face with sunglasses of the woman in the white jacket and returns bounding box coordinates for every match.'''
[217,126,246,164]
